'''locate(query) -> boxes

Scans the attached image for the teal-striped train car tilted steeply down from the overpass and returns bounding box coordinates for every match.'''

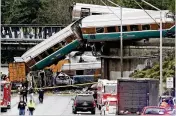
[21,20,82,70]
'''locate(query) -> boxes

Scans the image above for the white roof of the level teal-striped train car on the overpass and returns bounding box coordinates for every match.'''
[81,11,173,27]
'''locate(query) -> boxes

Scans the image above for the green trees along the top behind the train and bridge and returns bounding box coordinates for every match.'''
[1,0,175,24]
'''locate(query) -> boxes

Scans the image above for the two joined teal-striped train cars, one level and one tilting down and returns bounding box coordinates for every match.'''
[18,3,175,70]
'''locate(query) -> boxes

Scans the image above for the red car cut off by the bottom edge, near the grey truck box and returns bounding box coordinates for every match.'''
[141,106,170,116]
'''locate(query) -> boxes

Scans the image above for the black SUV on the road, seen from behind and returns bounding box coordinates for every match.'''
[72,94,96,114]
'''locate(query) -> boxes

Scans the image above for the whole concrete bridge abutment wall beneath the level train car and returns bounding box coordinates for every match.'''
[101,42,159,80]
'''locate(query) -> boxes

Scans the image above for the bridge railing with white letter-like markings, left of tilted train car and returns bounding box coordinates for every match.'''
[1,24,66,39]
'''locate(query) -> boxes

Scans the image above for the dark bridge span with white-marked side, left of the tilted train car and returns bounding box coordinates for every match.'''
[1,24,66,66]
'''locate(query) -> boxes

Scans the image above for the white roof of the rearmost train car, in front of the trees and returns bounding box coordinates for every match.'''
[74,3,152,14]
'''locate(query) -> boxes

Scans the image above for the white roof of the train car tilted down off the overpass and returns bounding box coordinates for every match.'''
[21,23,73,61]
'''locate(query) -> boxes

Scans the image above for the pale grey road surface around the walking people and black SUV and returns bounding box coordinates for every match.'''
[1,94,100,116]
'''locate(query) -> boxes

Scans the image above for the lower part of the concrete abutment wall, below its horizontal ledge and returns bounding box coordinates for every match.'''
[102,57,150,80]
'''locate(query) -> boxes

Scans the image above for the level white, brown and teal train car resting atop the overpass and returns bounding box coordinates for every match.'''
[81,10,175,42]
